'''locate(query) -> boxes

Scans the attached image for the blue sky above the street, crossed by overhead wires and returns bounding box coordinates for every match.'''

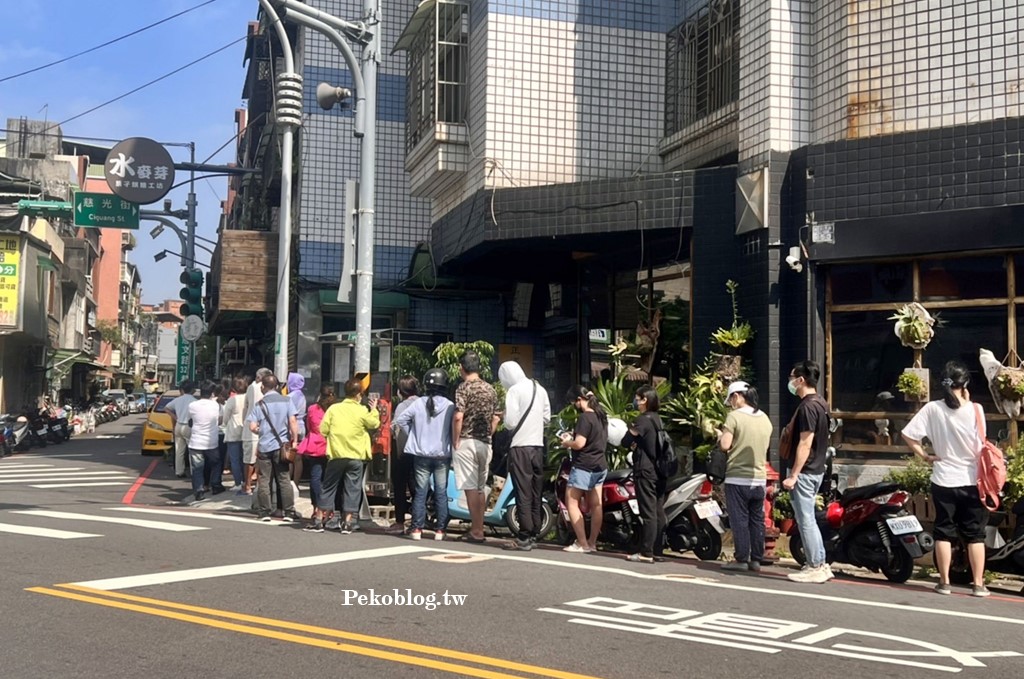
[0,0,259,303]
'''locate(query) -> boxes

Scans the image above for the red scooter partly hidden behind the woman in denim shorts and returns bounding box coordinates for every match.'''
[555,459,641,551]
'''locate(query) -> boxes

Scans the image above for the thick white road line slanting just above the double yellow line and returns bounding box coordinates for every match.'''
[74,546,430,591]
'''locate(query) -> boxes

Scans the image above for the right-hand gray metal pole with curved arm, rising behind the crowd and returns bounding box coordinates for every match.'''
[276,0,382,373]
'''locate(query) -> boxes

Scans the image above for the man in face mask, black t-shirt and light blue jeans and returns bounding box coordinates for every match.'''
[779,360,835,584]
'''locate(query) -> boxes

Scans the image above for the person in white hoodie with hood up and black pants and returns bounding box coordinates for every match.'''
[498,360,551,551]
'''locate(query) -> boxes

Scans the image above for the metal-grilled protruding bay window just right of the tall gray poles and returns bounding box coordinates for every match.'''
[406,0,469,152]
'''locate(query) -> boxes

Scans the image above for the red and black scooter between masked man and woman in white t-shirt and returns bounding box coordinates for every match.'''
[790,475,935,583]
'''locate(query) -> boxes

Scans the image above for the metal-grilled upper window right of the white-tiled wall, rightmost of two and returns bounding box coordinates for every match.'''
[665,0,739,136]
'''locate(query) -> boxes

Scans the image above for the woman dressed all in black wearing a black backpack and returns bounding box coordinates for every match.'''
[623,384,668,563]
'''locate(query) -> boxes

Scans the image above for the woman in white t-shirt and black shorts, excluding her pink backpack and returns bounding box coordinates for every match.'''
[903,360,988,596]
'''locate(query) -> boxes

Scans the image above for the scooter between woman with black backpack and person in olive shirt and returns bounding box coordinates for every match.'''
[665,474,725,561]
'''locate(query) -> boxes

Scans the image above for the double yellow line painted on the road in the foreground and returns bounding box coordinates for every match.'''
[27,584,593,679]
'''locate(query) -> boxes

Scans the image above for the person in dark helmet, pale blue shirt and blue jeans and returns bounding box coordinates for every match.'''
[394,368,455,541]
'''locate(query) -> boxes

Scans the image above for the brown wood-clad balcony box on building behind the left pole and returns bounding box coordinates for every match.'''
[207,229,278,334]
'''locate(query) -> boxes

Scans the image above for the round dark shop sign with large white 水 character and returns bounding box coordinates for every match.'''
[103,137,174,205]
